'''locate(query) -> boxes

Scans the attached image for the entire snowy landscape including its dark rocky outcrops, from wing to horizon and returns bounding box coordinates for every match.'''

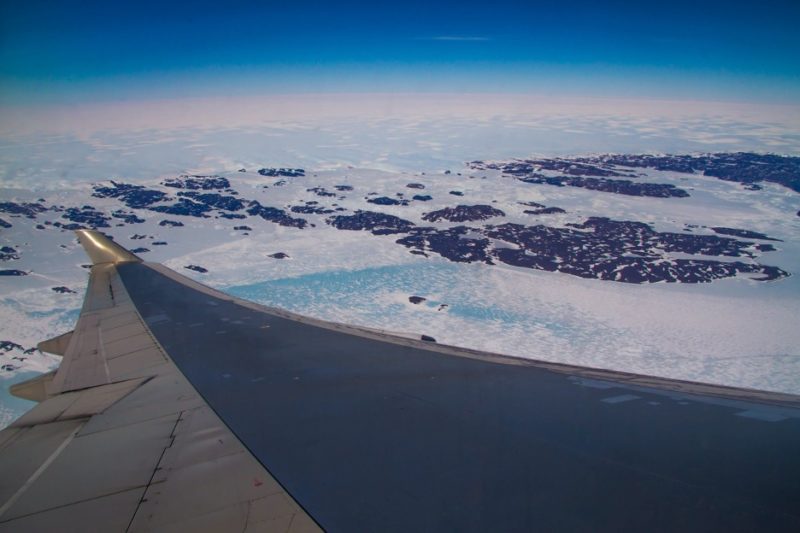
[0,96,800,426]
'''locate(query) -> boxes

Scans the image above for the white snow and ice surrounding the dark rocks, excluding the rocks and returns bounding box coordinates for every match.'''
[0,94,800,426]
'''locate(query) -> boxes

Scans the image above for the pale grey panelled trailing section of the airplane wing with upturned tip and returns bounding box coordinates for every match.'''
[0,231,319,532]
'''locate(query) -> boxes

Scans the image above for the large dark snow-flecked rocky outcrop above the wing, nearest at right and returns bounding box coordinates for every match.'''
[397,213,789,283]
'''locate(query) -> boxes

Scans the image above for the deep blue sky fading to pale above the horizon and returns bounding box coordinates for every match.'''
[0,0,800,104]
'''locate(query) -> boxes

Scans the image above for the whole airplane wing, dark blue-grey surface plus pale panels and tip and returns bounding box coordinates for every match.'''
[0,231,800,531]
